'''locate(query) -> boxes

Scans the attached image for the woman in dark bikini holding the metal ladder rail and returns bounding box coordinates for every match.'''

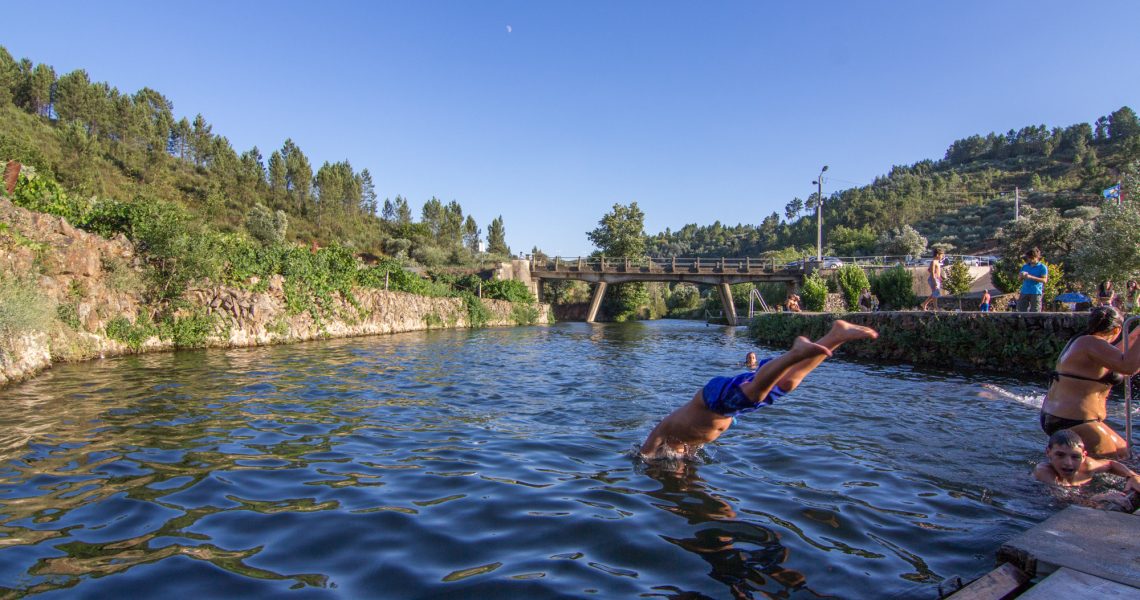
[1041,307,1140,457]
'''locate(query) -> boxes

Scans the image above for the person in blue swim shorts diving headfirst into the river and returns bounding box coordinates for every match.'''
[641,321,879,460]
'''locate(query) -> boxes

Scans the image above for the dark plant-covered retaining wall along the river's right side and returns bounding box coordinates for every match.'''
[749,311,1088,376]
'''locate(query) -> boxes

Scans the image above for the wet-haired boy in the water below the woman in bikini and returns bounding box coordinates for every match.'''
[1033,429,1140,512]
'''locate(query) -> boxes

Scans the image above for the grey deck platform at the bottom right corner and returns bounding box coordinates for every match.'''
[998,506,1140,589]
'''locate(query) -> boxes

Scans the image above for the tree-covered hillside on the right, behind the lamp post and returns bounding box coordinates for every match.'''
[649,106,1140,257]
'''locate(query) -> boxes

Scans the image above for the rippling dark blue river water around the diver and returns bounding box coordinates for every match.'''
[0,321,1094,599]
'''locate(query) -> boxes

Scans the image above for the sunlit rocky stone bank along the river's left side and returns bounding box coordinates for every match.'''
[0,197,549,384]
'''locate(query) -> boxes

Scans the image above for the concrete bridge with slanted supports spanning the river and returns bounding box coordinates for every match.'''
[529,257,805,325]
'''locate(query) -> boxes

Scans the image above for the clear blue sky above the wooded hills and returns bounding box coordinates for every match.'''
[0,0,1140,256]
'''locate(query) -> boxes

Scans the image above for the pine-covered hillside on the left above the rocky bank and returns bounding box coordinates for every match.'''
[0,47,511,266]
